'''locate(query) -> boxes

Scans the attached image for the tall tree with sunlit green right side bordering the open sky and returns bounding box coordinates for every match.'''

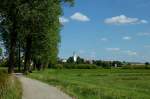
[23,0,74,71]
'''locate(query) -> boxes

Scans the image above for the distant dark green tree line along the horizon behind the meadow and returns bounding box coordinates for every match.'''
[61,56,150,69]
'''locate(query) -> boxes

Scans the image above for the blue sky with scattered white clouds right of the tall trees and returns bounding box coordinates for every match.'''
[59,0,150,62]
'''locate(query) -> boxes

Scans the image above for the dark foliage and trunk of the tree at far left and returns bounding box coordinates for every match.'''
[0,0,22,73]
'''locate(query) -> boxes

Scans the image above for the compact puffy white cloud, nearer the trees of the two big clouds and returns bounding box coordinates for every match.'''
[71,12,90,22]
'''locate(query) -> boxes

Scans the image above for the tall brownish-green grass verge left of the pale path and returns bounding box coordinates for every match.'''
[0,70,22,99]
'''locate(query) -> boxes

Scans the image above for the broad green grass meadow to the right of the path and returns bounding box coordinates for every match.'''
[29,69,150,99]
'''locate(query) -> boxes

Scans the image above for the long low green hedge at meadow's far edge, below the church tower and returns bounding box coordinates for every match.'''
[52,63,97,69]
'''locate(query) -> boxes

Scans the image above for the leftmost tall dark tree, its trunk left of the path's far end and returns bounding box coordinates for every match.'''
[0,0,19,73]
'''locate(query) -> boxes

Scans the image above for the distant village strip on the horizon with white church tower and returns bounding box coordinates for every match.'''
[58,52,146,67]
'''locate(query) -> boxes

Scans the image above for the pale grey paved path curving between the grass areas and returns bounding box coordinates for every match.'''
[18,76,72,99]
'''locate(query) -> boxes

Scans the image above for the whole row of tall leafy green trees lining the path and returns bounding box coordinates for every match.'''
[0,0,73,73]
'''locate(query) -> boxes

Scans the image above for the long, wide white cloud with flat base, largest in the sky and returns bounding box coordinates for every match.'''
[104,15,148,24]
